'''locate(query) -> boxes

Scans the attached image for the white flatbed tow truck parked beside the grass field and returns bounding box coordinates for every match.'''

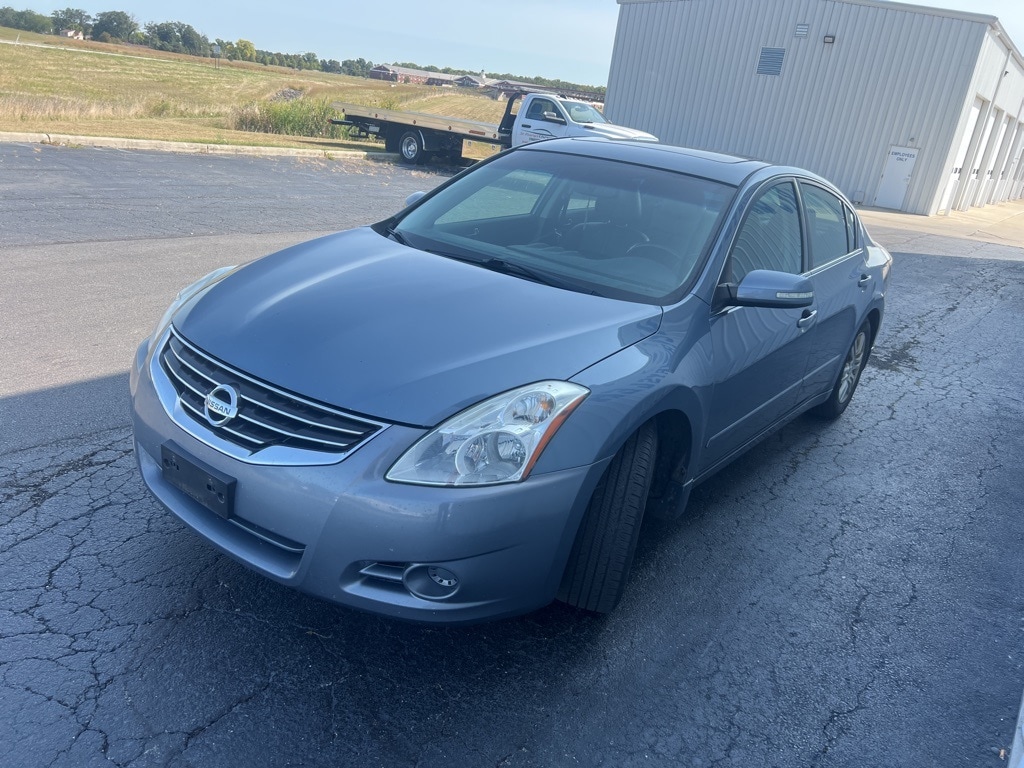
[331,92,657,164]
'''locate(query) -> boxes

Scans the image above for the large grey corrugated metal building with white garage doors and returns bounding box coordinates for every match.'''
[605,0,1024,214]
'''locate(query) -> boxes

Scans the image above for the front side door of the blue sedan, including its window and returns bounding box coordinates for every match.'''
[701,179,814,470]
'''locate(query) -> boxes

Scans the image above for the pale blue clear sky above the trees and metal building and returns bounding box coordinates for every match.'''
[22,0,1024,85]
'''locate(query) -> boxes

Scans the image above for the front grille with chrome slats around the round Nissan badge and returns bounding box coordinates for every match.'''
[160,329,383,454]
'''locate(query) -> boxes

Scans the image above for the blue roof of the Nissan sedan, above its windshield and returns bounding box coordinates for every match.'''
[518,136,771,186]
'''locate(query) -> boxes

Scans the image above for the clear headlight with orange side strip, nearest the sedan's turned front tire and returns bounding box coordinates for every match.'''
[386,381,590,485]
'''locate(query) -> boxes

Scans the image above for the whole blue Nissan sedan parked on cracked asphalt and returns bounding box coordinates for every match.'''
[131,139,892,624]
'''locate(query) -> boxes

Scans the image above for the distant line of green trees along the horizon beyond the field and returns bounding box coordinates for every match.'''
[0,6,604,92]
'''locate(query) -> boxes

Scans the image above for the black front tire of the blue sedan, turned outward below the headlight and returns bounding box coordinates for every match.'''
[558,422,657,613]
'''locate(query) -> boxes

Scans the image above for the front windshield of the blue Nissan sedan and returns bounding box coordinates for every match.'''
[385,151,735,304]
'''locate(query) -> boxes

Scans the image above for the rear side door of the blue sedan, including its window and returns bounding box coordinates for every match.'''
[799,179,871,399]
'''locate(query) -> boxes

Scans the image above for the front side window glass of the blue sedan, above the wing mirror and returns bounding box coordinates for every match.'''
[726,181,804,283]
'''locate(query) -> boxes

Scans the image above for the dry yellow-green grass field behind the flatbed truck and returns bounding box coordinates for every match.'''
[0,28,504,148]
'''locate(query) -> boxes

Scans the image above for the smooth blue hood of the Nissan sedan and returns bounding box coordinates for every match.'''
[174,227,662,426]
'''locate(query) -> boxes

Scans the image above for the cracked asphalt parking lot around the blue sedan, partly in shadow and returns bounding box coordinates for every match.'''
[0,144,1024,768]
